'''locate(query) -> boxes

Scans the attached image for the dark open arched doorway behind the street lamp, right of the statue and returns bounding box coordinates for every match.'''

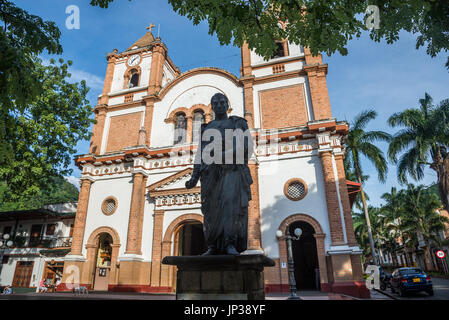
[289,221,320,291]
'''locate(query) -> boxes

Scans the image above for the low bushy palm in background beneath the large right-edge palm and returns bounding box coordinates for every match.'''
[402,184,449,270]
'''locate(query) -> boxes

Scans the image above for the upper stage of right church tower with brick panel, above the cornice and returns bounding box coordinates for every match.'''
[241,40,332,129]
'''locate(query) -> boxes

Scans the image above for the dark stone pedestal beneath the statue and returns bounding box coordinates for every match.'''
[162,254,275,300]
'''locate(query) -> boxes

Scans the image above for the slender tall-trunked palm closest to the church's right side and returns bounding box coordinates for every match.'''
[346,110,391,264]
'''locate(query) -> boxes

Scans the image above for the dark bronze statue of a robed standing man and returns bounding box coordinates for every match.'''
[186,93,253,255]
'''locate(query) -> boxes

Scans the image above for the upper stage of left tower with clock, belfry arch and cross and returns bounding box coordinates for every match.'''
[89,24,180,155]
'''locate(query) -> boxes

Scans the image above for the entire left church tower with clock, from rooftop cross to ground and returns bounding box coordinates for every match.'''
[58,25,180,290]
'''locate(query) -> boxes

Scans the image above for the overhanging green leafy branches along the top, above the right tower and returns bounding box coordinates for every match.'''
[91,0,449,68]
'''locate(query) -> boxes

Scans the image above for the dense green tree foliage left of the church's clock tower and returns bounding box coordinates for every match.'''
[0,0,94,201]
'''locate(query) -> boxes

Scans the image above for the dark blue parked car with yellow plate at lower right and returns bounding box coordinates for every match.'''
[390,268,433,297]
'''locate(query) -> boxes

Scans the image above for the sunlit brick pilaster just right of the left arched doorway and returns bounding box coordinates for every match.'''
[125,172,147,255]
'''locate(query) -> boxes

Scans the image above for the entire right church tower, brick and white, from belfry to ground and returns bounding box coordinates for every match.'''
[240,40,369,297]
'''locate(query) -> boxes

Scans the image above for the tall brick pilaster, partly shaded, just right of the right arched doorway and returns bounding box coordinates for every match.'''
[320,150,344,245]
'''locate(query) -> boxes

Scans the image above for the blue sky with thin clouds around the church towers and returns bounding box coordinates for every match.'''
[15,0,449,205]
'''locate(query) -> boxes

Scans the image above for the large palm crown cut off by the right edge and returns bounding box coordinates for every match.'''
[388,93,449,210]
